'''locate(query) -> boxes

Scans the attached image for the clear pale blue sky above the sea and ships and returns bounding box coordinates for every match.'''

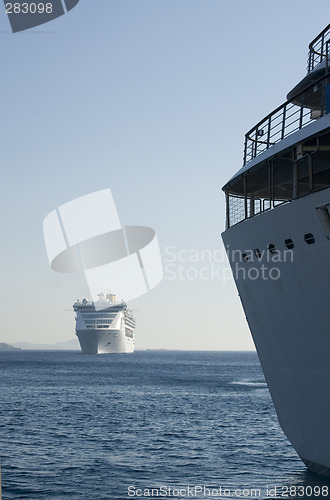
[0,0,330,350]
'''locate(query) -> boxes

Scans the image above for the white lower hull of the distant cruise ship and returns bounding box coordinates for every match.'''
[76,328,134,354]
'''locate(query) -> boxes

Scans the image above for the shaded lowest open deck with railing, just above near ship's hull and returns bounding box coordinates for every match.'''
[225,144,330,228]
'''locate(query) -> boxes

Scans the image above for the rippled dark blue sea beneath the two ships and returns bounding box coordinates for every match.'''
[0,350,330,500]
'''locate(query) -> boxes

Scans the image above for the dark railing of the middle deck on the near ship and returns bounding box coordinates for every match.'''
[243,73,330,165]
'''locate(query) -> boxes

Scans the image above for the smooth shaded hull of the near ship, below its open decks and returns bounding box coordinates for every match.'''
[222,189,330,475]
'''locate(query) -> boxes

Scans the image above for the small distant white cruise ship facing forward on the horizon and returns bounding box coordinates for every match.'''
[73,293,135,354]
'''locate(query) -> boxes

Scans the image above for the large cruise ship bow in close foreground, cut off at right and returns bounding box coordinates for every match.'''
[222,24,330,476]
